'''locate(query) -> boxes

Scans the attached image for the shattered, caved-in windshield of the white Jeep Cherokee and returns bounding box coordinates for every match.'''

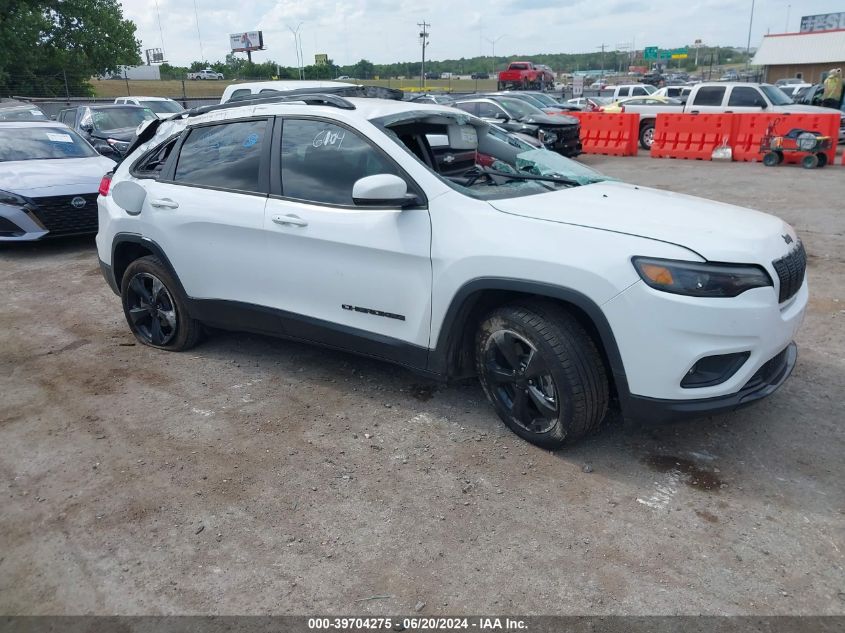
[373,113,610,200]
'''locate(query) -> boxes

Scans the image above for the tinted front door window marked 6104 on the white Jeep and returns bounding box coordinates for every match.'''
[281,119,402,205]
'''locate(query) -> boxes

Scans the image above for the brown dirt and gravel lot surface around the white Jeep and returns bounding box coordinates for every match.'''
[0,157,845,615]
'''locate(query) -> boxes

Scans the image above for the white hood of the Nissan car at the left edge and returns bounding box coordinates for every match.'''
[0,155,114,197]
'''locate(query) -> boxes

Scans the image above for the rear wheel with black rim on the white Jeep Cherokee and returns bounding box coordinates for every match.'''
[120,255,202,352]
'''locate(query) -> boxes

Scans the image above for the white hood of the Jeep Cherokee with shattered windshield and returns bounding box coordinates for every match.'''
[490,182,797,265]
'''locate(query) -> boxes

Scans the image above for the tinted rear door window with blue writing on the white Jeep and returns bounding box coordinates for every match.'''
[174,120,267,191]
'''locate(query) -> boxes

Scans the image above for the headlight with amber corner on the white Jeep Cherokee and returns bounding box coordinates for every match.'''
[631,257,773,297]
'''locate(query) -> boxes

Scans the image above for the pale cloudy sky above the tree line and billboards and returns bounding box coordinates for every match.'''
[122,0,845,66]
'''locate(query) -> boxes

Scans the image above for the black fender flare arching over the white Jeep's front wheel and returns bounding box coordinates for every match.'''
[428,277,629,397]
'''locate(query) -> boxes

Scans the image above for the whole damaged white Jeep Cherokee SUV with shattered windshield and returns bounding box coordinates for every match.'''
[97,94,807,448]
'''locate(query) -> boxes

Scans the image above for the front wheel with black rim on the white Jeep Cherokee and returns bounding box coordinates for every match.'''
[475,301,609,449]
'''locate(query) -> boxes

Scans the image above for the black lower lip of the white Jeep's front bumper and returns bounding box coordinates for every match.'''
[619,342,798,424]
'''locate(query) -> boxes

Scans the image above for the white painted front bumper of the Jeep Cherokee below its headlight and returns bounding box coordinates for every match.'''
[602,279,809,409]
